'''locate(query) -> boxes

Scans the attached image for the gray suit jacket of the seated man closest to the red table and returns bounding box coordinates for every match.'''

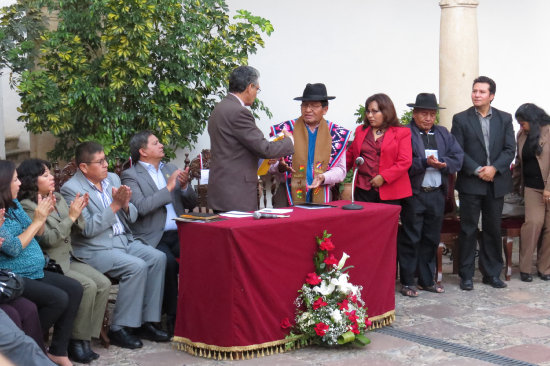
[121,163,197,248]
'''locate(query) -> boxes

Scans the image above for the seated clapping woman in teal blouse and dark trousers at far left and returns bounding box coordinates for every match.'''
[0,160,82,366]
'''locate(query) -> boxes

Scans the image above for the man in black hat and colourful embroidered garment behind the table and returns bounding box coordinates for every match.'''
[270,83,350,206]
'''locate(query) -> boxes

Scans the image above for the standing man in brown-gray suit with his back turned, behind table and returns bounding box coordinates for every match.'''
[208,66,294,211]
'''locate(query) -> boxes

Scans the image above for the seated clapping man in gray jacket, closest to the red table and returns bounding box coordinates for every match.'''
[121,131,197,335]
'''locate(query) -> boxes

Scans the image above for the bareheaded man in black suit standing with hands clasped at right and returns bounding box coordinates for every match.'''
[451,76,515,291]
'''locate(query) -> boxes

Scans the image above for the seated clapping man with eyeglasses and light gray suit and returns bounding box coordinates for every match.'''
[61,141,170,349]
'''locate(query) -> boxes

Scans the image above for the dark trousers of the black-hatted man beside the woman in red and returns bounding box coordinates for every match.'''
[397,190,445,287]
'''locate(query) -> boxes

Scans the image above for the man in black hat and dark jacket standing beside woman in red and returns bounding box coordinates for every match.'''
[397,93,464,297]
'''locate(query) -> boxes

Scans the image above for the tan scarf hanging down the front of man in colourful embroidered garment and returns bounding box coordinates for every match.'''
[291,117,332,204]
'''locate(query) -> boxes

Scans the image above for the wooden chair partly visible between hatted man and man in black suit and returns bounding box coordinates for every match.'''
[435,174,460,284]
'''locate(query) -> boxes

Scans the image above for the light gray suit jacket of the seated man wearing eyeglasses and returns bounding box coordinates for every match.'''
[61,170,138,273]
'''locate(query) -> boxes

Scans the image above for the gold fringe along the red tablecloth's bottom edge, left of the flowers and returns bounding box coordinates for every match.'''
[172,335,309,361]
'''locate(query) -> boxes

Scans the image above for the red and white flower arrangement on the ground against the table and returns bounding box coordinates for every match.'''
[281,230,372,346]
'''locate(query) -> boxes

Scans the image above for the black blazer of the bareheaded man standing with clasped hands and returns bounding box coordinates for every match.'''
[451,107,516,197]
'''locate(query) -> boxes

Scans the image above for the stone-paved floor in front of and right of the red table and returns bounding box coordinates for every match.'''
[83,249,550,366]
